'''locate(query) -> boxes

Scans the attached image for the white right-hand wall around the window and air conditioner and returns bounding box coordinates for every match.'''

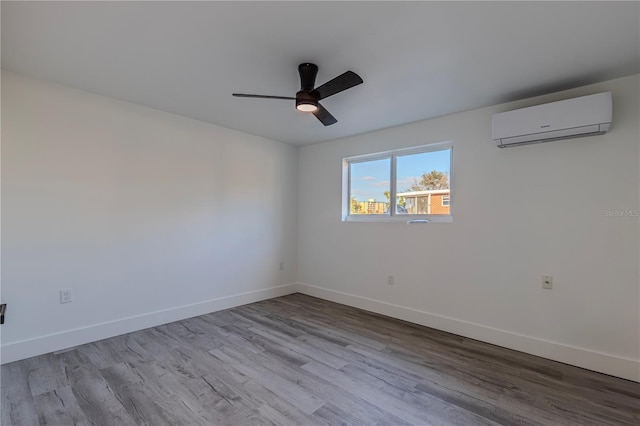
[298,75,640,380]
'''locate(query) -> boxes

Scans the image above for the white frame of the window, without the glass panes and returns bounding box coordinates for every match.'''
[342,141,454,223]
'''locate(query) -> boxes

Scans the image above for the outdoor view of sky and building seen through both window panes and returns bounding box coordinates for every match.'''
[349,148,451,215]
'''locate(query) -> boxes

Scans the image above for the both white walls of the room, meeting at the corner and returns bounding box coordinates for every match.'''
[0,72,640,380]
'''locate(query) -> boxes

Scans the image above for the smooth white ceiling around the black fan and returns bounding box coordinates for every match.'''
[1,1,640,145]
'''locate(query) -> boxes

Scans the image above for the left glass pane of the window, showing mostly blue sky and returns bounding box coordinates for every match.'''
[349,158,391,215]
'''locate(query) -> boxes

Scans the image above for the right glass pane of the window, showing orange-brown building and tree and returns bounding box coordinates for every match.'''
[396,149,451,215]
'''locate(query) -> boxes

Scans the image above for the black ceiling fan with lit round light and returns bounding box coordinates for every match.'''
[233,63,363,126]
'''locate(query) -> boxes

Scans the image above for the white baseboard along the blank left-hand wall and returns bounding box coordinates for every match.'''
[0,284,297,364]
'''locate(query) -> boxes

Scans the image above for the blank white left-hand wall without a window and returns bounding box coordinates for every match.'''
[2,72,297,362]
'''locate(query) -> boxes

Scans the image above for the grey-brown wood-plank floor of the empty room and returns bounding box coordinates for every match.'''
[1,294,640,426]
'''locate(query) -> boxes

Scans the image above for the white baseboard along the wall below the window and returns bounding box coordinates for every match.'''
[297,283,640,382]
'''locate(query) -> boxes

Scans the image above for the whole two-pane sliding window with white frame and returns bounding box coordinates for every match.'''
[342,142,453,221]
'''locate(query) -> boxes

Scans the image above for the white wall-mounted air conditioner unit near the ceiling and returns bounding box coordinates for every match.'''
[491,92,612,148]
